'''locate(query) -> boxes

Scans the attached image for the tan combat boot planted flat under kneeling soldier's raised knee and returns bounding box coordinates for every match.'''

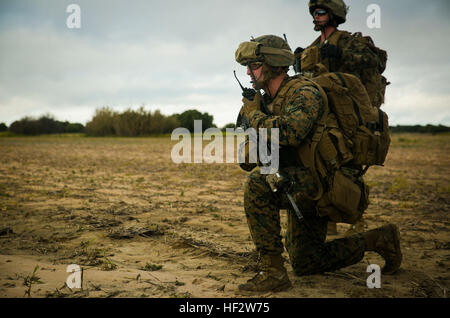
[238,255,292,292]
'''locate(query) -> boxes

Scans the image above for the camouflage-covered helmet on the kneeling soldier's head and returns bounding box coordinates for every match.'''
[235,35,295,67]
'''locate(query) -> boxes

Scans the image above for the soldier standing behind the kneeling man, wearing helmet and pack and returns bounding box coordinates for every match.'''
[294,0,388,234]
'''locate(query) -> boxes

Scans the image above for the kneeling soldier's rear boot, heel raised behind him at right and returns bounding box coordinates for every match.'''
[362,224,402,274]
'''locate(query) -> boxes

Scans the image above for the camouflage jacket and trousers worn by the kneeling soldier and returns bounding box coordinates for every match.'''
[244,78,365,275]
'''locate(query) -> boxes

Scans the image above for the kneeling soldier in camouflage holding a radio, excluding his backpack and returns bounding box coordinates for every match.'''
[235,35,402,293]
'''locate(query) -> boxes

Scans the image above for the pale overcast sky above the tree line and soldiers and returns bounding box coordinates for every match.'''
[0,0,450,127]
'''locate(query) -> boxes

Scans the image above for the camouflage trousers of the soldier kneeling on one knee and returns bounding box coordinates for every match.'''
[244,168,365,275]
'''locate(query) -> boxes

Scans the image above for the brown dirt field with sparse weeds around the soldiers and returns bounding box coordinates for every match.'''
[0,134,450,297]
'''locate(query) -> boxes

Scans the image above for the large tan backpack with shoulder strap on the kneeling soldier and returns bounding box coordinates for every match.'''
[268,73,390,224]
